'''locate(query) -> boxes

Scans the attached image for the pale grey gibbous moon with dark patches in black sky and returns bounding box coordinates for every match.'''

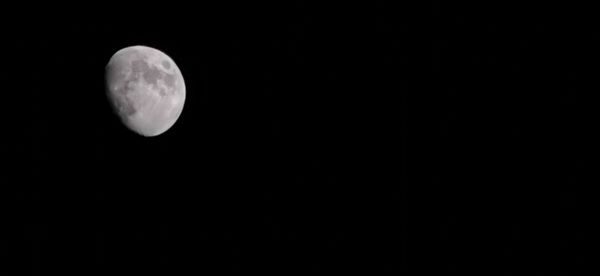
[105,45,185,137]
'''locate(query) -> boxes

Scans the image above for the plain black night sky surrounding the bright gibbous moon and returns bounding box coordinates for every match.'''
[0,1,588,275]
